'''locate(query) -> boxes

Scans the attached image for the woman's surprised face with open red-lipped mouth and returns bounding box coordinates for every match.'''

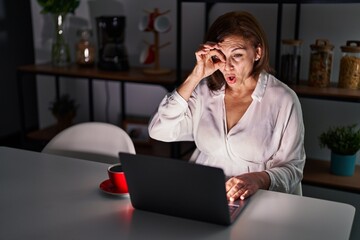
[218,36,261,85]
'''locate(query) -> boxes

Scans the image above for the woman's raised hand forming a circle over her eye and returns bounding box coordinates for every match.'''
[192,42,226,79]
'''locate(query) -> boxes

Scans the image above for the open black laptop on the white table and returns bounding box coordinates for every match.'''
[119,152,249,225]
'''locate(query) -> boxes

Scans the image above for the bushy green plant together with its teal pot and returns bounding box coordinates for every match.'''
[319,124,360,176]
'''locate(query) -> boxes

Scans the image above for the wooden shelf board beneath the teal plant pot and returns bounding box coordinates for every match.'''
[302,158,360,193]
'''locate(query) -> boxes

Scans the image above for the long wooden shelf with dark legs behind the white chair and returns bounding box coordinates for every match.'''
[17,63,188,149]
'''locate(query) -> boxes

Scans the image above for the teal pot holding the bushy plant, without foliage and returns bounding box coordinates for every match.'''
[330,152,356,176]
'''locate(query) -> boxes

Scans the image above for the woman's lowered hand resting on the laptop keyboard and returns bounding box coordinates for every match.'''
[225,172,270,201]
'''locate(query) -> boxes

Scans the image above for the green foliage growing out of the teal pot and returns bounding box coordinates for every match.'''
[319,124,360,155]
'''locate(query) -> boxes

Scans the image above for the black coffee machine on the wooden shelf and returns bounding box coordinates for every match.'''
[96,16,129,71]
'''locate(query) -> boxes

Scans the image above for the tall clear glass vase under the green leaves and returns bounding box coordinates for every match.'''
[51,13,70,67]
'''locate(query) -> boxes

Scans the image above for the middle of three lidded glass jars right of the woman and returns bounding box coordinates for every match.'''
[309,39,334,88]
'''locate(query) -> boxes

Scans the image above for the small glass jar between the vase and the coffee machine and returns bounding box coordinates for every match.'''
[76,29,95,67]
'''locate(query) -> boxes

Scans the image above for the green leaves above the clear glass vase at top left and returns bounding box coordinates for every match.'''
[37,0,80,14]
